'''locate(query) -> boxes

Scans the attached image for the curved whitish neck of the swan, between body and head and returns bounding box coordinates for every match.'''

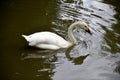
[68,22,80,44]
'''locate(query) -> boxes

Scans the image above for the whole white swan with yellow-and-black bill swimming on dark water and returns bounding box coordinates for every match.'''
[22,21,92,50]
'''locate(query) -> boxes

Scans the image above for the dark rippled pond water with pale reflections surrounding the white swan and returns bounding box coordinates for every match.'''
[0,0,120,80]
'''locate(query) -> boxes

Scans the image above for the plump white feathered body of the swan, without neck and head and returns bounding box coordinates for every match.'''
[22,32,69,48]
